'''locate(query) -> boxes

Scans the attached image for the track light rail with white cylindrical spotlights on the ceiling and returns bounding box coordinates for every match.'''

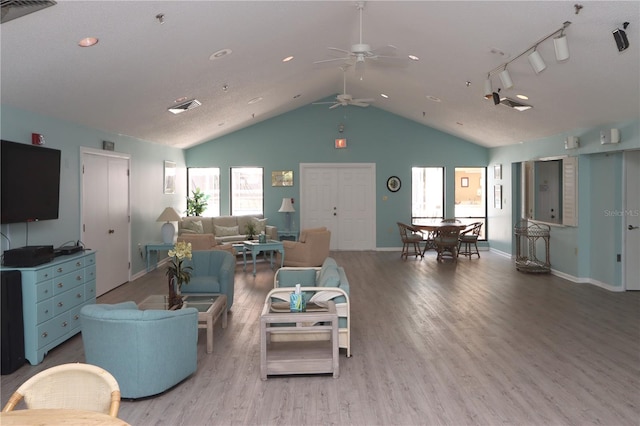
[484,21,571,101]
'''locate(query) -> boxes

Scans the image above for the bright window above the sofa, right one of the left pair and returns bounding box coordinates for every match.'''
[230,167,264,216]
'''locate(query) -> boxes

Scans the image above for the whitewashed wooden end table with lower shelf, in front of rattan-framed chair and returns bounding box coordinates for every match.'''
[260,288,340,380]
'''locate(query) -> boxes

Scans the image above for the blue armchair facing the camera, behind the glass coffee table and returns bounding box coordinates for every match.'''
[181,250,236,310]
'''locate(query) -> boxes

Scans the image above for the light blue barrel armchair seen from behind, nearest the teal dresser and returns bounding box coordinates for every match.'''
[80,302,198,398]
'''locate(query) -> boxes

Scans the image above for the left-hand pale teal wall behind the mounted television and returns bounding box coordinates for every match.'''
[0,105,186,274]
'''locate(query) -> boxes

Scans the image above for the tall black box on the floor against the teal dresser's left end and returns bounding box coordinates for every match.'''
[0,271,25,374]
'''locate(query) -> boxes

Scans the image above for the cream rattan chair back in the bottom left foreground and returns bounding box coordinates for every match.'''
[2,363,120,417]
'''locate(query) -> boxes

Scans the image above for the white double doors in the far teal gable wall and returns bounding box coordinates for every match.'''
[300,164,376,250]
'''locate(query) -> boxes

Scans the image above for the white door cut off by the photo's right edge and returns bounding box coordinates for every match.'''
[623,151,640,290]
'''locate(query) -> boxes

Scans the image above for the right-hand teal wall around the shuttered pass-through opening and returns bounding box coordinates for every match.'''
[489,120,640,289]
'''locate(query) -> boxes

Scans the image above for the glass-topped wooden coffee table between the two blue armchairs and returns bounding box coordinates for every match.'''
[138,294,227,354]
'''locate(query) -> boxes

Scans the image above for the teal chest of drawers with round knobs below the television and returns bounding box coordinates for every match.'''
[2,252,96,365]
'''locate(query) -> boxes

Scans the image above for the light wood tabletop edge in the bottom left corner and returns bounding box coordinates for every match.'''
[0,408,129,426]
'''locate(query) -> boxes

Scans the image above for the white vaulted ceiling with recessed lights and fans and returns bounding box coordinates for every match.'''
[0,0,640,147]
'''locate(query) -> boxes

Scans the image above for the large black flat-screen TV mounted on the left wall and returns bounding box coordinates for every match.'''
[0,140,60,223]
